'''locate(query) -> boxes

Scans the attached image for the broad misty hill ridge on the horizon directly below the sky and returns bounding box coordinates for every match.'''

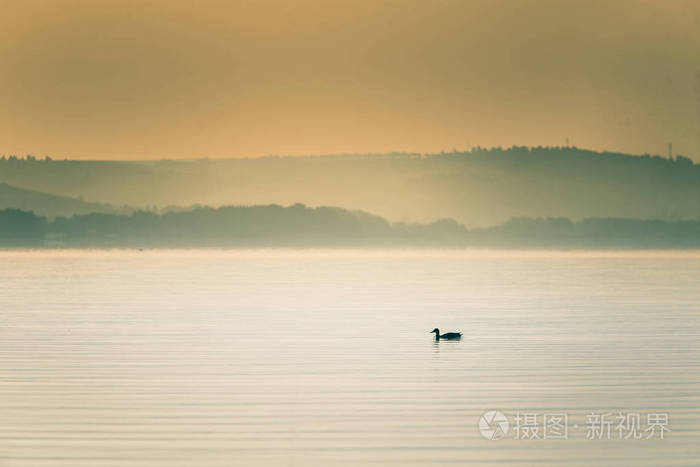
[0,147,700,227]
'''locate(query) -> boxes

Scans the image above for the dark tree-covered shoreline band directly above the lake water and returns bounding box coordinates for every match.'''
[0,204,700,249]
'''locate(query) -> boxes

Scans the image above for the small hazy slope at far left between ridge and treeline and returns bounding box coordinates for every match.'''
[0,183,117,218]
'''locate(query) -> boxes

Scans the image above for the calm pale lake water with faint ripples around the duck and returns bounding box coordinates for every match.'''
[0,250,700,467]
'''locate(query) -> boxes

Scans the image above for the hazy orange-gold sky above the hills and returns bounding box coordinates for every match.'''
[0,0,700,162]
